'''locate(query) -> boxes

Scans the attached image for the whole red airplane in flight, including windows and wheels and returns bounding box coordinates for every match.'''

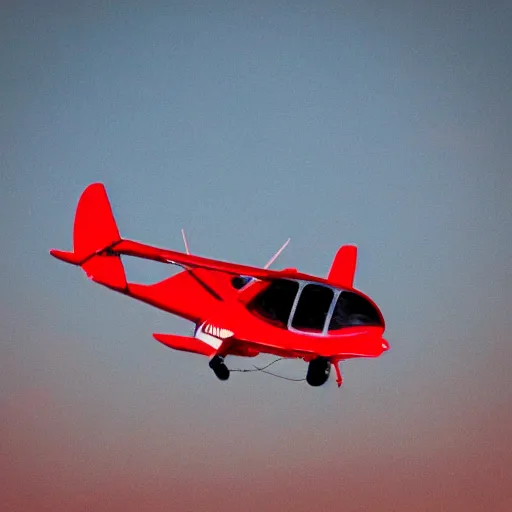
[50,183,389,387]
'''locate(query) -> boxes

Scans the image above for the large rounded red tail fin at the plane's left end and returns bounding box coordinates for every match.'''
[50,183,127,291]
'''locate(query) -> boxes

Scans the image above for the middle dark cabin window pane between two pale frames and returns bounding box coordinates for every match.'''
[292,283,334,333]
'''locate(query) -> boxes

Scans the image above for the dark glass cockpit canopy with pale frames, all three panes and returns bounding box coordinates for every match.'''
[248,279,383,334]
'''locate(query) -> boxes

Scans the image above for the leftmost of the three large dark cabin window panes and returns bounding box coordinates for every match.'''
[249,279,299,328]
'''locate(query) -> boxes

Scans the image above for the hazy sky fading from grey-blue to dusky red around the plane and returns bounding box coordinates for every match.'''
[0,0,512,512]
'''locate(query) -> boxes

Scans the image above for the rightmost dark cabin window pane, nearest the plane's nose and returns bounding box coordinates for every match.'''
[329,292,382,331]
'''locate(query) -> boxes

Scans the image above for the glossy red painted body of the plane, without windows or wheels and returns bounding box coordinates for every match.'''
[50,183,389,385]
